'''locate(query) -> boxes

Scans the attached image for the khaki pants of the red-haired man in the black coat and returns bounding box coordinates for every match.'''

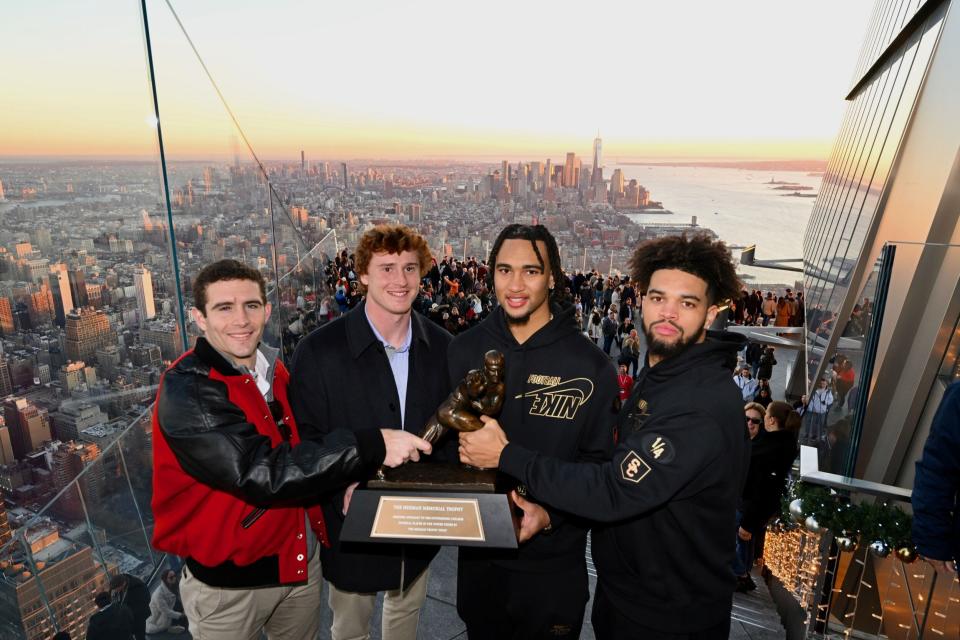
[327,569,430,640]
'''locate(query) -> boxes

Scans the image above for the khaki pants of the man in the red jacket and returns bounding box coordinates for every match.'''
[180,550,322,640]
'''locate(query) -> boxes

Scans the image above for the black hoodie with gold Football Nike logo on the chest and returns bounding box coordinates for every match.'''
[447,306,619,571]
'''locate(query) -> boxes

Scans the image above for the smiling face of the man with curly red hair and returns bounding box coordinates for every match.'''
[360,251,420,315]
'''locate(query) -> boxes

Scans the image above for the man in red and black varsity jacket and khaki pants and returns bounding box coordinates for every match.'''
[152,260,430,640]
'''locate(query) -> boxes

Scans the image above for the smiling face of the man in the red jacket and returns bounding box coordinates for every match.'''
[191,280,270,369]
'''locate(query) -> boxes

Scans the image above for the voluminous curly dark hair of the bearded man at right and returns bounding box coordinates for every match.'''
[629,233,742,305]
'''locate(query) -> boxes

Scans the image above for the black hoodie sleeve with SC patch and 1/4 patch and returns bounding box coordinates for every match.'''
[500,411,722,522]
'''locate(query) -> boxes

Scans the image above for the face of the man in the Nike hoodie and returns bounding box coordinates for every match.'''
[493,238,553,330]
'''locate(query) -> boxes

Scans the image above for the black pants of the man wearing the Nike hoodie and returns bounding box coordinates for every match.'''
[457,553,590,640]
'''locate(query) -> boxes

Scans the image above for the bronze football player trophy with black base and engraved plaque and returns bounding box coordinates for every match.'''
[341,351,519,548]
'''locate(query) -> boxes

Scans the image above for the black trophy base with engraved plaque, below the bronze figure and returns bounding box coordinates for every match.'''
[340,464,519,549]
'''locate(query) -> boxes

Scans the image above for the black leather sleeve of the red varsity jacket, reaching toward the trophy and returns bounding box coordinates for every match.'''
[157,370,369,507]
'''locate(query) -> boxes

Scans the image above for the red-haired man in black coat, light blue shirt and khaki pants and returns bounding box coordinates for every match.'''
[290,225,452,640]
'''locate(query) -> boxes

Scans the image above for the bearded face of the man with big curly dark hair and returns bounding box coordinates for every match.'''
[643,269,718,365]
